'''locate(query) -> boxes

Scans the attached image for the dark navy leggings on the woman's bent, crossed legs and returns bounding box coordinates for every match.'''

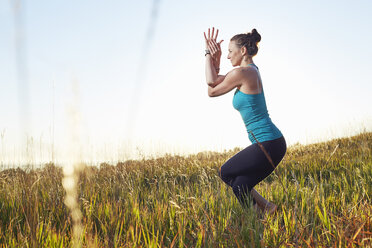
[220,136,287,206]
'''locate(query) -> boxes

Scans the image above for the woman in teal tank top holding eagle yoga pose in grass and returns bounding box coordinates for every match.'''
[204,28,287,214]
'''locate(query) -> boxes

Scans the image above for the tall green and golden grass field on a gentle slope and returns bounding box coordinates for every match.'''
[0,132,372,247]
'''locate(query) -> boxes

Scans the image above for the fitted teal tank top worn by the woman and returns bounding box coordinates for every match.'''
[233,64,283,144]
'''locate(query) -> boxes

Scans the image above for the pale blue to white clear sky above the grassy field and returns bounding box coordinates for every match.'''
[0,0,372,167]
